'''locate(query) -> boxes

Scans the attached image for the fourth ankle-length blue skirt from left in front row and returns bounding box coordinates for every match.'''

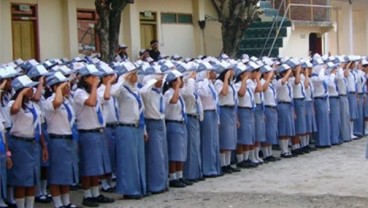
[200,110,221,176]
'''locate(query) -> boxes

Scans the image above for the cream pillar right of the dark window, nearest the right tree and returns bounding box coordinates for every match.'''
[192,0,207,56]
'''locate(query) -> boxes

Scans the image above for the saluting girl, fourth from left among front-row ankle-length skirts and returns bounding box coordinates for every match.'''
[197,62,222,178]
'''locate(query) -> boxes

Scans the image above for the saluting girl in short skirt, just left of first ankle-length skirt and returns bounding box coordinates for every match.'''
[73,65,114,207]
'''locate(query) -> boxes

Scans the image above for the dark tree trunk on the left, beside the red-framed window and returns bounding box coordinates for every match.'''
[95,0,129,62]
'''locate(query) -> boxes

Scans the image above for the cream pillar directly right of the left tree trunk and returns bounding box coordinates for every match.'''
[120,3,141,61]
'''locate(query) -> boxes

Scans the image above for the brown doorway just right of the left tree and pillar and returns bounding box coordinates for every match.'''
[139,11,157,49]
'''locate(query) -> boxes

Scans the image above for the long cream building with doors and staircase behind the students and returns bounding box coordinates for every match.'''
[0,0,368,63]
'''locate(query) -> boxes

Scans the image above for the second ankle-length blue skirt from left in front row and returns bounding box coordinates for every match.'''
[145,119,169,192]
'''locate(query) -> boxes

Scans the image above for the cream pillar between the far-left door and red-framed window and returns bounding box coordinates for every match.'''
[63,0,78,58]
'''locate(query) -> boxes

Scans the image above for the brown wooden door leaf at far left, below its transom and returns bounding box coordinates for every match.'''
[12,20,37,60]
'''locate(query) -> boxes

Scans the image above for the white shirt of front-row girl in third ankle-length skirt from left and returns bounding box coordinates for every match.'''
[181,78,203,120]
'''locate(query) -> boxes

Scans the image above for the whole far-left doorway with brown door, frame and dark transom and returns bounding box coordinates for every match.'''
[11,4,39,60]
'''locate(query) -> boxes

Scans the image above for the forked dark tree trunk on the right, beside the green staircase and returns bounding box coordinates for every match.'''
[211,0,261,57]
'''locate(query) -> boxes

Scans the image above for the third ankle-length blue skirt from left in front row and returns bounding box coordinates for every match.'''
[183,115,202,179]
